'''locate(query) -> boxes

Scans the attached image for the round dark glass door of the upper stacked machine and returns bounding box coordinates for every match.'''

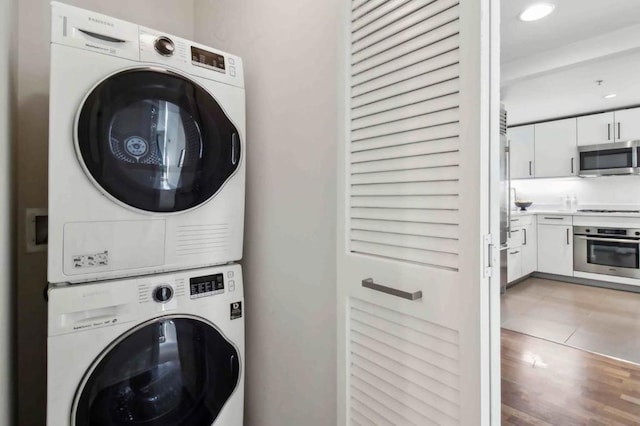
[76,69,241,212]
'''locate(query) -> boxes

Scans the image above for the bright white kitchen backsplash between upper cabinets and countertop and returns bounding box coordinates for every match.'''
[511,176,640,209]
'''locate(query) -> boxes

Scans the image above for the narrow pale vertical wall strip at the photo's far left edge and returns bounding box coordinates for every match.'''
[0,0,17,425]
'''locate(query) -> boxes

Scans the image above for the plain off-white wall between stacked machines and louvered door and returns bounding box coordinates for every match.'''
[195,0,343,426]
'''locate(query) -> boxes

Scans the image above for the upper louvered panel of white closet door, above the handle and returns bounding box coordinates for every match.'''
[349,0,461,270]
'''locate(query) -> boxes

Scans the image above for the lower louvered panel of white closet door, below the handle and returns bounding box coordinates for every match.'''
[349,298,460,426]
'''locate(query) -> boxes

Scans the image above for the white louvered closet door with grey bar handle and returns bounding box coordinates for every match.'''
[338,0,499,426]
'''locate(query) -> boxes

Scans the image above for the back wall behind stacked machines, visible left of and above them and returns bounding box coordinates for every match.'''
[14,0,194,426]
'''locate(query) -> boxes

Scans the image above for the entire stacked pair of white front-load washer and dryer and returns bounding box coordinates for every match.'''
[47,2,245,426]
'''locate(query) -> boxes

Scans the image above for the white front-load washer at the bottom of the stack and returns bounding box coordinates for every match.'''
[47,265,244,426]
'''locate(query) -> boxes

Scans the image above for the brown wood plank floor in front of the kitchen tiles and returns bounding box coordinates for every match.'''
[502,330,640,426]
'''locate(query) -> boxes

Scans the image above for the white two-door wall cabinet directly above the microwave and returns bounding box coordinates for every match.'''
[578,108,640,146]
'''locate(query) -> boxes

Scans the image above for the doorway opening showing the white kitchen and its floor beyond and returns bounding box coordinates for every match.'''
[501,0,640,424]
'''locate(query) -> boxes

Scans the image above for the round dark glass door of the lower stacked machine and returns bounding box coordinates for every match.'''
[71,317,240,426]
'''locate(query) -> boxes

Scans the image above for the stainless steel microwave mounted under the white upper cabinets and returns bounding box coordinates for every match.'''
[578,141,640,176]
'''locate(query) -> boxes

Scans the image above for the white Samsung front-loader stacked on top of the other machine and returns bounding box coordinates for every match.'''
[48,2,245,283]
